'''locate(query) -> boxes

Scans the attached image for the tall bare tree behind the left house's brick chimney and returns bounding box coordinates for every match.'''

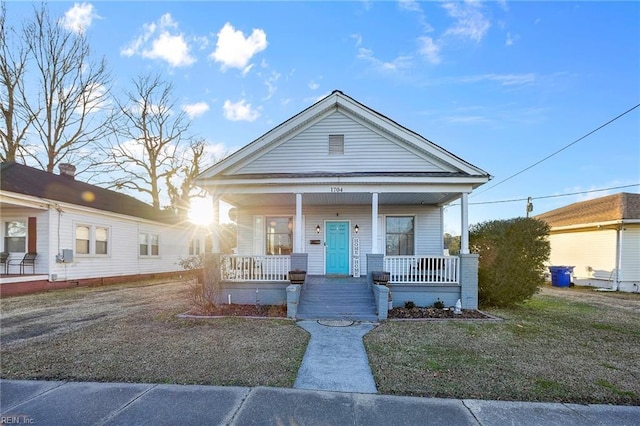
[23,5,110,172]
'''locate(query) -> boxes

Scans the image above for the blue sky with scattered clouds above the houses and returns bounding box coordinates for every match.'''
[7,1,640,233]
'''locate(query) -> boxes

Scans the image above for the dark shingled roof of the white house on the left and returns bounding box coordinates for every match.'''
[0,162,176,223]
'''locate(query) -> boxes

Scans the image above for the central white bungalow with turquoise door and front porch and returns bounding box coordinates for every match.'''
[197,91,490,315]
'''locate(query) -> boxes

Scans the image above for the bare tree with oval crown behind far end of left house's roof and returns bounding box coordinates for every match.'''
[107,75,190,209]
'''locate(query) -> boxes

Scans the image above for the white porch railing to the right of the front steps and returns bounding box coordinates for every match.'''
[384,256,460,284]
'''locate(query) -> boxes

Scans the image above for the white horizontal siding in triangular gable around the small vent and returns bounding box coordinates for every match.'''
[231,112,452,173]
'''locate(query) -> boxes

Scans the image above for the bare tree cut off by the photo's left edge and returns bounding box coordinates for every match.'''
[0,3,33,161]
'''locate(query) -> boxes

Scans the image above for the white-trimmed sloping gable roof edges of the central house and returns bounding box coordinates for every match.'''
[196,90,490,184]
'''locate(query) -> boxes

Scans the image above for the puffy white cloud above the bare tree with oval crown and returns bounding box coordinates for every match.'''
[120,13,196,67]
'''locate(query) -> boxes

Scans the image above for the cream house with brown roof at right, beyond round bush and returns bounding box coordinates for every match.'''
[536,193,640,293]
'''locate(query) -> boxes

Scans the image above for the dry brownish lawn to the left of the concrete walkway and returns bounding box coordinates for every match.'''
[0,283,309,386]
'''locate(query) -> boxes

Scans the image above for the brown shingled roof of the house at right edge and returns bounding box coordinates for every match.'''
[536,192,640,228]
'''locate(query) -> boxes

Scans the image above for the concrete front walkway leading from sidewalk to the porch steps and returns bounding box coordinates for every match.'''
[293,320,377,393]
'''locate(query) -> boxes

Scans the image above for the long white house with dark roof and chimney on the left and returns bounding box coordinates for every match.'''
[0,163,203,294]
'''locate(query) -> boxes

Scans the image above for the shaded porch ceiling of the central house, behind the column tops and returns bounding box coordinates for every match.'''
[222,192,460,207]
